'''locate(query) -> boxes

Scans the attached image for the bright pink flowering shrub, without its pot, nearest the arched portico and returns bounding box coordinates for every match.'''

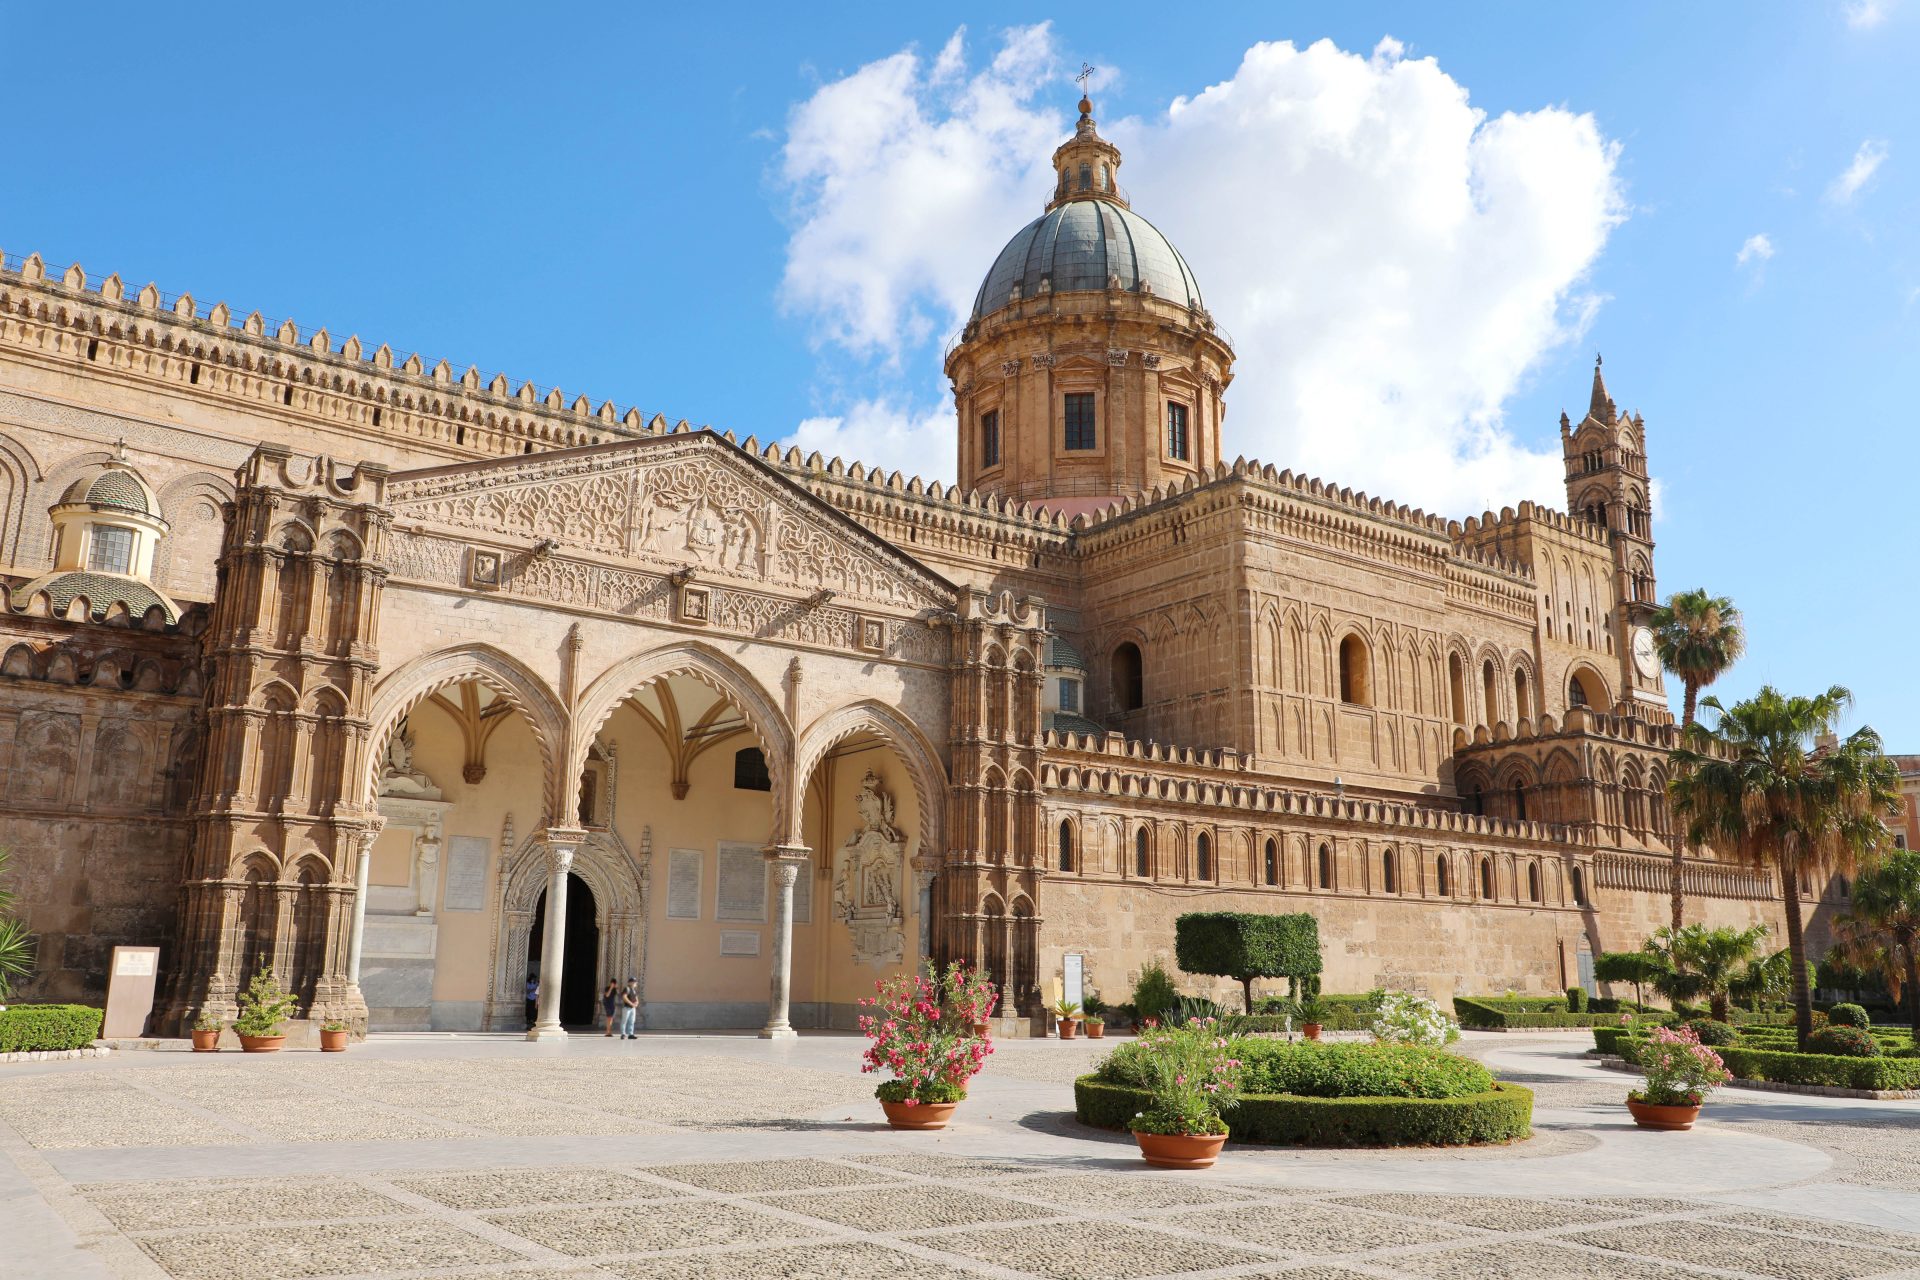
[860,961,998,1107]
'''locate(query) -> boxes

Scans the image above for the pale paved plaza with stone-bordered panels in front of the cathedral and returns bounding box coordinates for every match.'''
[0,1034,1920,1280]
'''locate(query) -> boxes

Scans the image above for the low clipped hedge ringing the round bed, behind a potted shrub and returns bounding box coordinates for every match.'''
[1073,1075,1534,1148]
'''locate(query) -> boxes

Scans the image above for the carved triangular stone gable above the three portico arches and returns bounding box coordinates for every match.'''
[388,432,952,610]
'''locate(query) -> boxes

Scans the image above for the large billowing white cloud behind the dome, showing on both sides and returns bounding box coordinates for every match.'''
[781,25,1624,514]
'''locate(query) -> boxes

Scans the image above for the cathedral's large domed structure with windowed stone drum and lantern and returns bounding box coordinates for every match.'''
[947,98,1233,514]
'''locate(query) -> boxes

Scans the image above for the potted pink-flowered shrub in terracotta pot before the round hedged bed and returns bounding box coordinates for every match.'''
[1127,1017,1240,1169]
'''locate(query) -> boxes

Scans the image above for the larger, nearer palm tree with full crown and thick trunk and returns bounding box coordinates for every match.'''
[1670,685,1899,1044]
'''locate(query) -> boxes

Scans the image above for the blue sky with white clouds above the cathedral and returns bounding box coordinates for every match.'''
[0,0,1920,750]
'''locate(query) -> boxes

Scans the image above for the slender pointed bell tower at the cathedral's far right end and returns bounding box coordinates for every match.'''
[1561,355,1667,712]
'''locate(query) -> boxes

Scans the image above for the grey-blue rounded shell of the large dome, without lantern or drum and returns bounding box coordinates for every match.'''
[973,200,1200,320]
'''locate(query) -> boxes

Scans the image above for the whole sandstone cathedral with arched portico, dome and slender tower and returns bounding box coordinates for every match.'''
[0,100,1780,1038]
